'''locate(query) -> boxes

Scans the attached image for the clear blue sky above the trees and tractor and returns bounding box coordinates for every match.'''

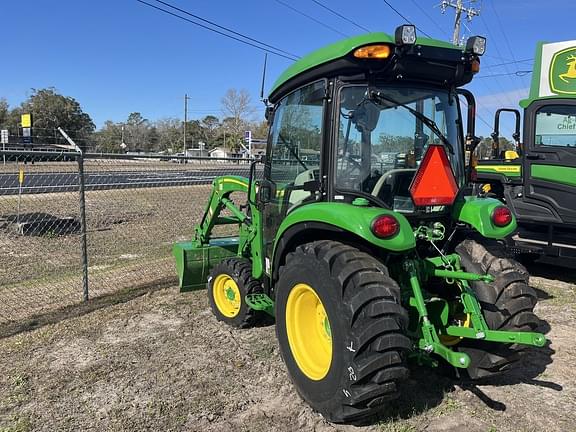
[0,0,576,135]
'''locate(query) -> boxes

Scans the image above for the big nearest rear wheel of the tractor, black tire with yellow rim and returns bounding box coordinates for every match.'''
[276,240,412,423]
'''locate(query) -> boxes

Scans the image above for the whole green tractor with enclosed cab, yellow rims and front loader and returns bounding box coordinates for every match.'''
[173,25,546,423]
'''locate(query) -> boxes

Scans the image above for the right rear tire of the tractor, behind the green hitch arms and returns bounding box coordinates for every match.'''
[456,240,540,379]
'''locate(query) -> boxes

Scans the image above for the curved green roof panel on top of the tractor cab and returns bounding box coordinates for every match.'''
[270,33,462,94]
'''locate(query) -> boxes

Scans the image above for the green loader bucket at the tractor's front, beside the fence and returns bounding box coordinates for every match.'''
[172,237,238,292]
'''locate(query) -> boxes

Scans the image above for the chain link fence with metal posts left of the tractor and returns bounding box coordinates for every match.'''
[0,151,250,334]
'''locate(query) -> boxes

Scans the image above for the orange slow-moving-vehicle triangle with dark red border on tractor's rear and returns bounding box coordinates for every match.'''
[410,144,458,206]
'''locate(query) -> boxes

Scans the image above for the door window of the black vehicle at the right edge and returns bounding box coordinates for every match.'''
[535,105,576,147]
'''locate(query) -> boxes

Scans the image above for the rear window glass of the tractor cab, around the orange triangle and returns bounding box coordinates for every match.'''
[336,86,464,212]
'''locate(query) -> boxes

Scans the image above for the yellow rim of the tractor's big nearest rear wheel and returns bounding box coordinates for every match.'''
[286,283,332,381]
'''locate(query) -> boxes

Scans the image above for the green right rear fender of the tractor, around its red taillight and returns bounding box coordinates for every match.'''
[452,197,517,239]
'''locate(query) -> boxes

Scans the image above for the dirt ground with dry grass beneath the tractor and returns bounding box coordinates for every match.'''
[0,268,576,432]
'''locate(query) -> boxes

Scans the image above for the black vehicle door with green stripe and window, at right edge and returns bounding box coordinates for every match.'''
[519,99,576,224]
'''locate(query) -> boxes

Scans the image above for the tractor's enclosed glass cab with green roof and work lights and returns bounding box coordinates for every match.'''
[260,26,485,246]
